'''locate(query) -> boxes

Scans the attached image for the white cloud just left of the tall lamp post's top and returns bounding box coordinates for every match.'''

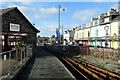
[40,7,58,15]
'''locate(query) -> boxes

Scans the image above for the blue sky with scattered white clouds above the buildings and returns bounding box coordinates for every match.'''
[0,0,118,37]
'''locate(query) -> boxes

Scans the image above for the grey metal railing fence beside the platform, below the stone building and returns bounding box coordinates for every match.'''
[0,46,32,77]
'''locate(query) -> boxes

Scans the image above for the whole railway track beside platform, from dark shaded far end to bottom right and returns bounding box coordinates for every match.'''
[43,49,120,80]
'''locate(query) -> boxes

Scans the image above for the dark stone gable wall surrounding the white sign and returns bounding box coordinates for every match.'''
[2,8,37,45]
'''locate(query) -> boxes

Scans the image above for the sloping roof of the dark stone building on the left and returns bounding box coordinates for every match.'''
[0,7,40,33]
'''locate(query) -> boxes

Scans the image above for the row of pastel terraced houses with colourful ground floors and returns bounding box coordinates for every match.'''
[74,9,120,49]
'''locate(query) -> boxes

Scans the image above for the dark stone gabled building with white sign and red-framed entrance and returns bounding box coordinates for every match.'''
[0,7,40,51]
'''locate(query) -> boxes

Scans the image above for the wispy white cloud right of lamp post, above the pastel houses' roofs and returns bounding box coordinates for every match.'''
[72,9,97,21]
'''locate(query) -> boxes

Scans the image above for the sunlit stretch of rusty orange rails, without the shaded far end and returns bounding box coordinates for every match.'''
[59,56,120,80]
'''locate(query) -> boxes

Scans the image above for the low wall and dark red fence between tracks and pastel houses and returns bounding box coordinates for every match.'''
[51,46,120,61]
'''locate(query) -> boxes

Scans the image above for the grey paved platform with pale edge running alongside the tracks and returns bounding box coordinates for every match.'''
[19,47,75,80]
